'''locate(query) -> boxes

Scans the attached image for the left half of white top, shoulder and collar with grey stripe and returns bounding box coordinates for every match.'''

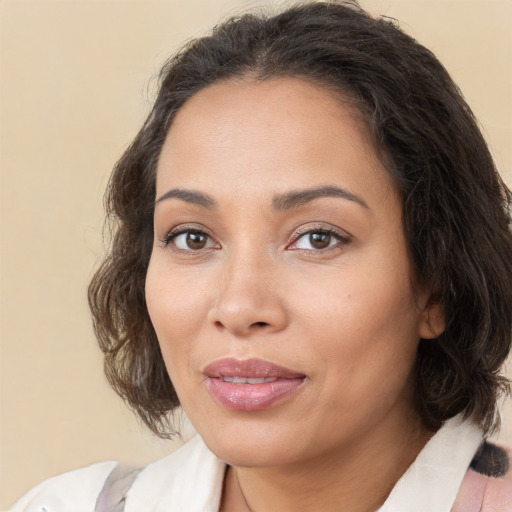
[9,436,226,512]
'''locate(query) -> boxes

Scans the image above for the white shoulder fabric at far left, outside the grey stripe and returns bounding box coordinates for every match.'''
[9,461,118,512]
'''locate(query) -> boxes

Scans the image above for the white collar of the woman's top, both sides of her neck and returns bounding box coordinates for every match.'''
[125,419,482,512]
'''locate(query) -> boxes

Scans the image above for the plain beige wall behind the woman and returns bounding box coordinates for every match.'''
[0,0,512,508]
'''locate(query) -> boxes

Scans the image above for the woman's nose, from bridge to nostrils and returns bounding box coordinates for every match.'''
[208,251,288,338]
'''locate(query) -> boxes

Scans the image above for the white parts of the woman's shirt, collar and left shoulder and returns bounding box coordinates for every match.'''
[11,418,509,512]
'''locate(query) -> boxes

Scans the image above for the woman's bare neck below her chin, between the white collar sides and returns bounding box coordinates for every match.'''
[221,412,432,512]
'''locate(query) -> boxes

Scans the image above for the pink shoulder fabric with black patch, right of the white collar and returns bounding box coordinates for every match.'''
[452,442,512,512]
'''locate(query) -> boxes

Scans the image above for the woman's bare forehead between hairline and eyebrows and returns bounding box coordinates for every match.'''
[157,77,392,206]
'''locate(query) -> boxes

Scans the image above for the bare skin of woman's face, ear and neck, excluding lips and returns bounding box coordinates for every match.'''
[146,78,443,512]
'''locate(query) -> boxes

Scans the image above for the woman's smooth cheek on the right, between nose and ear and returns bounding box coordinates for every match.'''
[288,258,420,398]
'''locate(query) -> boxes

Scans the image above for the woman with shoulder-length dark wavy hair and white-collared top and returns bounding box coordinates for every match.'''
[14,2,512,512]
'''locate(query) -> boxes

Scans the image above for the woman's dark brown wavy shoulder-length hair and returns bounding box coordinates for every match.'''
[89,2,512,437]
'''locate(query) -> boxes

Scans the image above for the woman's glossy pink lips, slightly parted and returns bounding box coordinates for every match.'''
[203,358,306,411]
